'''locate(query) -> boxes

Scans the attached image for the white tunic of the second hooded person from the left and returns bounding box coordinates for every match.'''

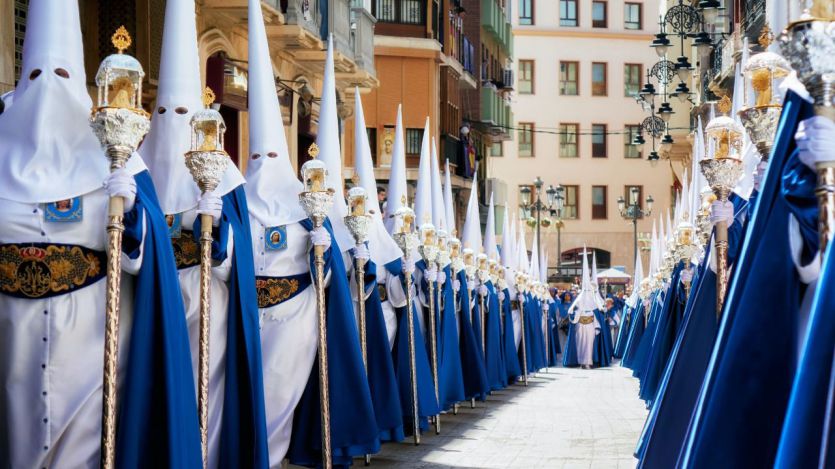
[177,209,234,468]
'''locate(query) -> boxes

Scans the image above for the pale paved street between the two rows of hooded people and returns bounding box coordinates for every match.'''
[372,366,646,469]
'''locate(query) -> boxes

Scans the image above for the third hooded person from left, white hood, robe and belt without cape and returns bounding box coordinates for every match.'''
[244,4,330,467]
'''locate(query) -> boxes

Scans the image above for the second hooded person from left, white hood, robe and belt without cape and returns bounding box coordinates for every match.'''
[138,1,244,467]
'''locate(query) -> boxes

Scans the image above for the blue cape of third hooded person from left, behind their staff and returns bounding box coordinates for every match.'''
[287,220,380,467]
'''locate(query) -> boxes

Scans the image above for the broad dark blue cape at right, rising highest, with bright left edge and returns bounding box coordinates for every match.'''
[682,92,816,467]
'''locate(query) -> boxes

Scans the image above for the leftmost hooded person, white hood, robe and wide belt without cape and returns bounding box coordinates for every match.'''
[0,0,199,468]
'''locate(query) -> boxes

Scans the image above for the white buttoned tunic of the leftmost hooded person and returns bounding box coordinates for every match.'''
[0,189,142,468]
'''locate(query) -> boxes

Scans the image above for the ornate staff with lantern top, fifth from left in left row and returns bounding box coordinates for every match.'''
[392,205,420,445]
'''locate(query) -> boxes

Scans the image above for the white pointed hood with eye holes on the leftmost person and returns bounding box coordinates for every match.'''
[0,0,116,203]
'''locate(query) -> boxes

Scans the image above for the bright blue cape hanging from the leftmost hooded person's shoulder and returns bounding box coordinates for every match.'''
[116,171,203,468]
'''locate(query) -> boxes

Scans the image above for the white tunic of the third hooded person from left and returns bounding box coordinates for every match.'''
[250,217,318,468]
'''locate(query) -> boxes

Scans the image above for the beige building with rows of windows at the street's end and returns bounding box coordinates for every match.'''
[487,0,681,277]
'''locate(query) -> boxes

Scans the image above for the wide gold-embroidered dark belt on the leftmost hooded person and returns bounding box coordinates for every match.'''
[0,243,107,299]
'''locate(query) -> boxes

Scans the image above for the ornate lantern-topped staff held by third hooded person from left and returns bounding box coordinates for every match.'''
[299,143,334,469]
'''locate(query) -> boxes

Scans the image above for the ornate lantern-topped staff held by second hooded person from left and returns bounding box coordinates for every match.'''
[185,88,229,467]
